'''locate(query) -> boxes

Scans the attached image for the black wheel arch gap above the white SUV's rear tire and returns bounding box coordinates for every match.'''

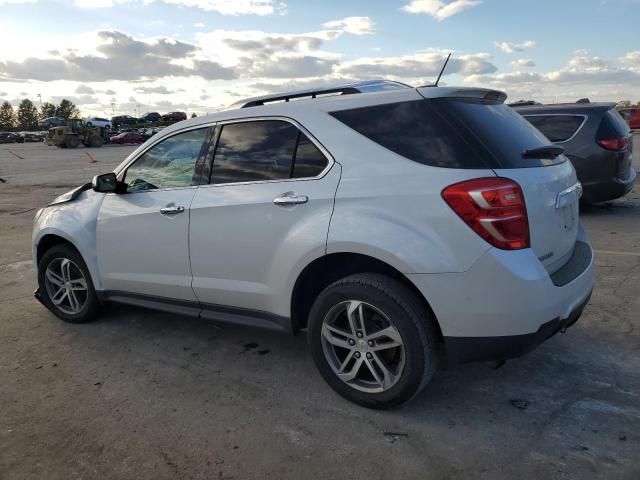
[291,252,442,339]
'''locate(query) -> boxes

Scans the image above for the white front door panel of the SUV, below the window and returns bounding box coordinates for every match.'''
[97,187,196,301]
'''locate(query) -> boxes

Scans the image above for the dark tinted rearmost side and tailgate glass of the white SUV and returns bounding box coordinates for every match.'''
[331,98,564,169]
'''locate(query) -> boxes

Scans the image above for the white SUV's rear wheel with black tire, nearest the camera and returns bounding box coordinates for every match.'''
[308,273,440,409]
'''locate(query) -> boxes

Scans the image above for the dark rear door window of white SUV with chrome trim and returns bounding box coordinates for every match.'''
[211,120,327,184]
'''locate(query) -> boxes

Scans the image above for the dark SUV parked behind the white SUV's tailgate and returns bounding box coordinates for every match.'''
[512,102,636,203]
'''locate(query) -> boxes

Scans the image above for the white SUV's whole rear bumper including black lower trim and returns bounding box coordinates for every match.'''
[408,229,594,362]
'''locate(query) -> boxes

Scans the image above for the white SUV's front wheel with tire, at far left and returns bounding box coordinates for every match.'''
[38,244,100,323]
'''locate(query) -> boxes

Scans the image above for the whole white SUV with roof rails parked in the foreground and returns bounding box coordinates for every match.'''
[33,82,593,408]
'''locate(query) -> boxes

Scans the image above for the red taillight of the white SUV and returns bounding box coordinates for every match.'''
[442,177,530,250]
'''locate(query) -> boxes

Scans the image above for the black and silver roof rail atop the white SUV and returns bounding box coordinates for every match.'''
[231,80,412,108]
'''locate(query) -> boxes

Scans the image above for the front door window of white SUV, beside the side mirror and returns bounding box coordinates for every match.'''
[125,128,207,192]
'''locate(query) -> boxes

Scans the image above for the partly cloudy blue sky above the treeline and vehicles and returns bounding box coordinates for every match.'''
[0,0,640,116]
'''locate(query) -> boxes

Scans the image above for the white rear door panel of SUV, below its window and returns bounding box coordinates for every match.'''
[190,164,340,317]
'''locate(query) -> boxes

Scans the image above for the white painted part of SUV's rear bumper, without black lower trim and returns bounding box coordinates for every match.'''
[407,229,594,337]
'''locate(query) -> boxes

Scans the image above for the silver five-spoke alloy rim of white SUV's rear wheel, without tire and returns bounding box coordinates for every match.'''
[321,300,405,393]
